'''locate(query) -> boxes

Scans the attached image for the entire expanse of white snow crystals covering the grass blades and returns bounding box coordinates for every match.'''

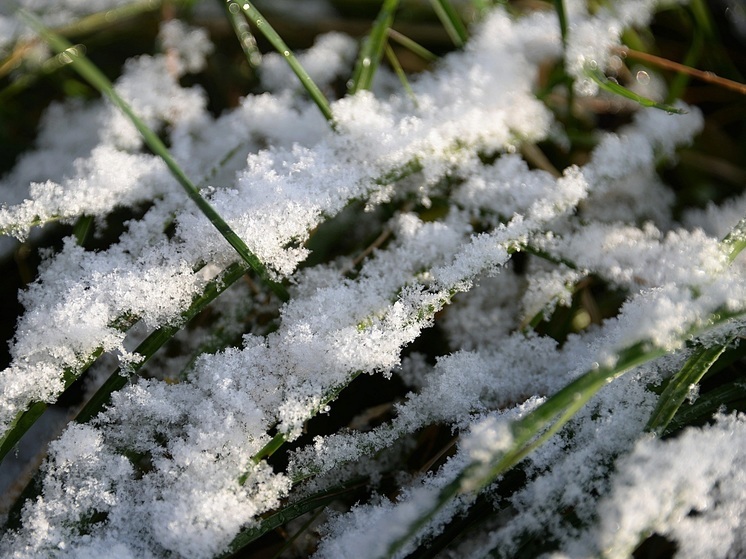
[0,1,746,558]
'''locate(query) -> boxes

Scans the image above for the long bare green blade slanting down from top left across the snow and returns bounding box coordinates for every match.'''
[17,9,289,301]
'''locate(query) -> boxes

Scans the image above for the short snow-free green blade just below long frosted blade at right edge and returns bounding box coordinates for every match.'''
[645,337,733,436]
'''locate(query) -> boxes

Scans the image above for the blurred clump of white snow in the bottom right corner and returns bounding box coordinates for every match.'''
[568,414,746,558]
